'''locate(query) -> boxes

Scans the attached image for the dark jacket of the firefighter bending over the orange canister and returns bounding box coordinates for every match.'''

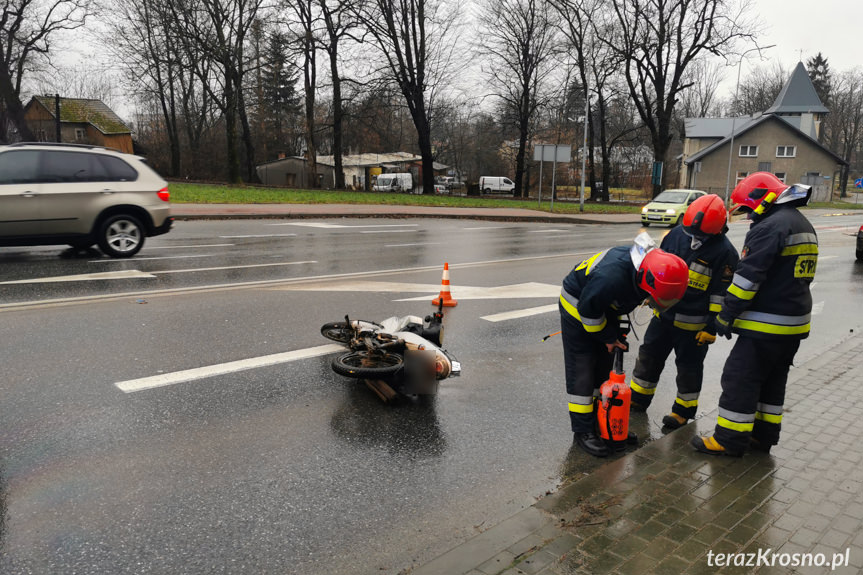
[560,246,647,343]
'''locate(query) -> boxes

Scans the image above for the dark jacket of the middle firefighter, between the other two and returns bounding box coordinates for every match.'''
[659,226,738,333]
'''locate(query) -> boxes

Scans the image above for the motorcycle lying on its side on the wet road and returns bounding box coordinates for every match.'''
[321,306,461,402]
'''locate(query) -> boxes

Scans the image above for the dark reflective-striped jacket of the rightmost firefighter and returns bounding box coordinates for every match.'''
[717,204,818,339]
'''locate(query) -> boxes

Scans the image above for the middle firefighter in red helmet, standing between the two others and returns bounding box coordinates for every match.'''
[629,194,738,429]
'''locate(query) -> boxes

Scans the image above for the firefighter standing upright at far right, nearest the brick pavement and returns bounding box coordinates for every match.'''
[692,172,818,456]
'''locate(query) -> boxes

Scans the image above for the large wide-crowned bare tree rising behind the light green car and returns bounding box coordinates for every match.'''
[600,0,755,195]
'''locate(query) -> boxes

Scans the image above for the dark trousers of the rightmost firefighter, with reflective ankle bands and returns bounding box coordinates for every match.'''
[714,336,800,451]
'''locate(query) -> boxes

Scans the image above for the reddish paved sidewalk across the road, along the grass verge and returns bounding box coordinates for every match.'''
[171,204,641,224]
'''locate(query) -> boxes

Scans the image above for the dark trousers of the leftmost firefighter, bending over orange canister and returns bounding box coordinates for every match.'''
[560,306,613,433]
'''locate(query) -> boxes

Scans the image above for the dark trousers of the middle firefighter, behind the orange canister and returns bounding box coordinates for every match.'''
[629,316,708,419]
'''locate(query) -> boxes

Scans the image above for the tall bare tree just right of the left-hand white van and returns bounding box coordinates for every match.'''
[357,0,457,194]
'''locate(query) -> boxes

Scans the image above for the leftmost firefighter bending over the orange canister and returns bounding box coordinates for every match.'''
[559,233,688,457]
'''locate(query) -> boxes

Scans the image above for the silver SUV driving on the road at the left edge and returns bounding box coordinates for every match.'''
[0,142,173,258]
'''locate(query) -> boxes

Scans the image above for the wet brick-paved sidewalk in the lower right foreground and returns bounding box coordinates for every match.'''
[410,335,863,575]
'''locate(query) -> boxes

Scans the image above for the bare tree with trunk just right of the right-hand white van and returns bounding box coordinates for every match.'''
[480,0,557,196]
